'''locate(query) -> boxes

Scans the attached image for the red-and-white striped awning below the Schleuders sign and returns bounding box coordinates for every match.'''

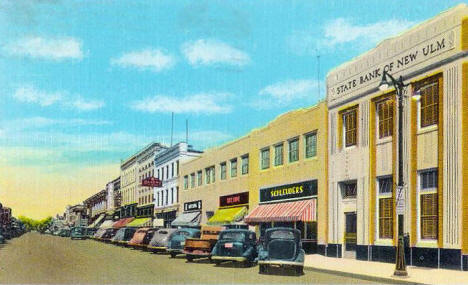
[244,199,317,224]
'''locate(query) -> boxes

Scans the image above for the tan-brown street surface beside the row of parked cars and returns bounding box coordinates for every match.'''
[0,232,380,284]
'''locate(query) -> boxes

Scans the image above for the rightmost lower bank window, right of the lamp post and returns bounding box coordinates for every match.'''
[420,170,439,239]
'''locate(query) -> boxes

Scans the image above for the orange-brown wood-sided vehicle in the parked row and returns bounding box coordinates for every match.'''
[183,226,224,262]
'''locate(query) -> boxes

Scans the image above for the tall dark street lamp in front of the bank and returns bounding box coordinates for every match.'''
[379,70,412,276]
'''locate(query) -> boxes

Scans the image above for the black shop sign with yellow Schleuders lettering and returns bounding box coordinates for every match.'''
[260,180,317,203]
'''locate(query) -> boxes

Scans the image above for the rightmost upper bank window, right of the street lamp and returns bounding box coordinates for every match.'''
[419,79,439,128]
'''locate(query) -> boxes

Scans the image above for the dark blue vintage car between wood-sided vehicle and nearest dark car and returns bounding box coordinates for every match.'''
[211,229,257,267]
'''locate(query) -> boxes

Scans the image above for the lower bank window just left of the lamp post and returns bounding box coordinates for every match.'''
[378,177,393,239]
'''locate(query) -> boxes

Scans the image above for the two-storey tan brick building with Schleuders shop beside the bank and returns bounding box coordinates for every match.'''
[179,103,328,251]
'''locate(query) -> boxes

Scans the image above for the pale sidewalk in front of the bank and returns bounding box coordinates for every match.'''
[304,254,468,284]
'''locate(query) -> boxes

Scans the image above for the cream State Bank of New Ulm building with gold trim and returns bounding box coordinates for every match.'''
[326,4,468,270]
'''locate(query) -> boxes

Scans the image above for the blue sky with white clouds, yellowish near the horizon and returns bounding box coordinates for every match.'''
[0,0,461,218]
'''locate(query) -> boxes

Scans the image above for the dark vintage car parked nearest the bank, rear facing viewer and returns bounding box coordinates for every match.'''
[257,227,305,274]
